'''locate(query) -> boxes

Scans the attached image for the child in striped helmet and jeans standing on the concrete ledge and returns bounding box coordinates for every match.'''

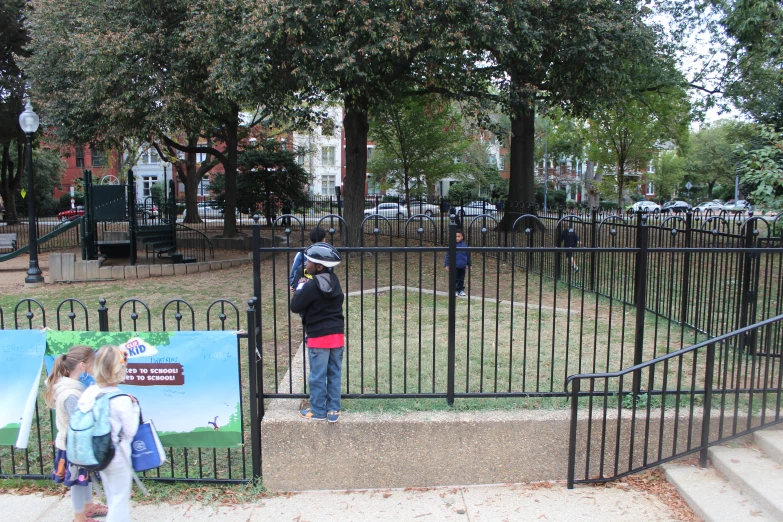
[290,243,345,422]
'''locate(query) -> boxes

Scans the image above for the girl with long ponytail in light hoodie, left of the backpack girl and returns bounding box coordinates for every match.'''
[44,346,107,522]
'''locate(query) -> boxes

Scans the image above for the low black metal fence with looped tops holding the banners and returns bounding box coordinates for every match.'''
[0,298,261,483]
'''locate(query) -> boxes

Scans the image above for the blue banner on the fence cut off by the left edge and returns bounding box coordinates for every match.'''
[0,330,46,449]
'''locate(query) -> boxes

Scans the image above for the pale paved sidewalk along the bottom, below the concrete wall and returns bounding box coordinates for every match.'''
[0,484,679,522]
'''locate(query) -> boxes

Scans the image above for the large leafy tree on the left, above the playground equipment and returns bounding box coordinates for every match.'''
[30,0,304,237]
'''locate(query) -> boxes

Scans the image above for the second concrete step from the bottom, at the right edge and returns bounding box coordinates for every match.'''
[709,446,783,520]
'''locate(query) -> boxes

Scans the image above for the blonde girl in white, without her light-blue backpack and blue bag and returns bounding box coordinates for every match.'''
[78,345,139,522]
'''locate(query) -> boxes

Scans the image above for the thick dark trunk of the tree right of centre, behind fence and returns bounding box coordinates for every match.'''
[500,104,536,230]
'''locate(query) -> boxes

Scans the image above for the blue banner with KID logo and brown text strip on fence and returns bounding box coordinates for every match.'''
[46,331,242,448]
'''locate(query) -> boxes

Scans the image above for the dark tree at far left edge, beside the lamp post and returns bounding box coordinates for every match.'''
[0,0,29,223]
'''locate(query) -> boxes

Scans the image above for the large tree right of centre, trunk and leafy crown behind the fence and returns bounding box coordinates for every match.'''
[466,0,656,228]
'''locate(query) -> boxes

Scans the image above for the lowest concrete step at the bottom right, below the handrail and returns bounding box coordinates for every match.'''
[663,463,775,522]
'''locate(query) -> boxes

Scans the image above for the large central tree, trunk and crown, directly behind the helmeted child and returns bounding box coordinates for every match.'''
[260,0,475,244]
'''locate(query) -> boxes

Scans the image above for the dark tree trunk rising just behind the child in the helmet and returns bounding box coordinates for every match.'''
[343,98,370,246]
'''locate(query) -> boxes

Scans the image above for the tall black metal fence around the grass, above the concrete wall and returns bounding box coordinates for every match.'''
[254,211,783,398]
